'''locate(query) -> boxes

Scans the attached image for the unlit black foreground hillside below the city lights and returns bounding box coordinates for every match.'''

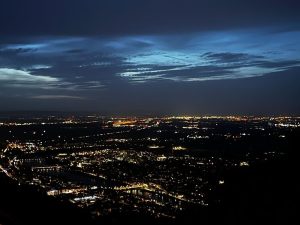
[0,155,300,225]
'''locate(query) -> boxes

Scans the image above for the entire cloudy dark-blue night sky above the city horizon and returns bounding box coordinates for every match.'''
[0,0,300,115]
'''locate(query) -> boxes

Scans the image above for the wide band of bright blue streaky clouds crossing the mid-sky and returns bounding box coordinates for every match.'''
[0,30,300,91]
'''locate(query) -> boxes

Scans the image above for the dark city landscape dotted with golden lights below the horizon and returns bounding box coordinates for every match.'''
[0,115,300,225]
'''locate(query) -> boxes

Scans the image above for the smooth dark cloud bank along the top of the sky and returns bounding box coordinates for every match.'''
[0,0,300,36]
